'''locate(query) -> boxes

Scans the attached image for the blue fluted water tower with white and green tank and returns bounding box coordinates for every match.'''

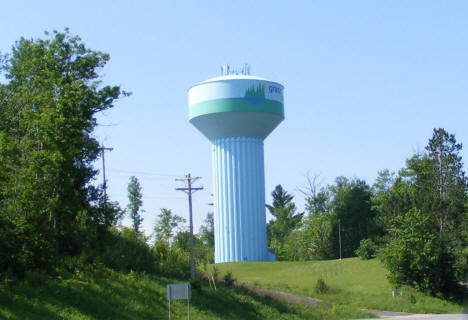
[188,65,284,263]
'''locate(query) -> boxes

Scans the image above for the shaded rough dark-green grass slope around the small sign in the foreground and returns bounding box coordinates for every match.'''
[0,269,369,320]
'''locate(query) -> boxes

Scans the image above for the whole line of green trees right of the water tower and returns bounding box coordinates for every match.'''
[267,128,468,294]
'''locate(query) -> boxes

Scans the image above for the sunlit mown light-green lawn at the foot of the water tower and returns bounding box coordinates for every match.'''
[216,258,463,313]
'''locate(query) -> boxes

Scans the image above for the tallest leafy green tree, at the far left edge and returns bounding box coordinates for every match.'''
[0,30,125,273]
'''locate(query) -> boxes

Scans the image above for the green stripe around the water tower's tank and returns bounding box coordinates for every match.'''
[189,98,284,119]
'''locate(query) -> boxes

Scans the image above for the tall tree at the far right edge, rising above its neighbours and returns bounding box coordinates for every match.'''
[382,129,468,294]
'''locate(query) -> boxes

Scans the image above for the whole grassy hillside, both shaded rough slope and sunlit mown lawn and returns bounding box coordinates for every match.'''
[0,259,462,320]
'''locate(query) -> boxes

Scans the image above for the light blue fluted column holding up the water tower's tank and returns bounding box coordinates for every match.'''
[212,137,274,263]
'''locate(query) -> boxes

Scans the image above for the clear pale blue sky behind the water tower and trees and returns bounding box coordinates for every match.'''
[0,0,468,234]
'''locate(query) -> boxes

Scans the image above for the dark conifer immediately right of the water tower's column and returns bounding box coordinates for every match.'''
[266,185,304,259]
